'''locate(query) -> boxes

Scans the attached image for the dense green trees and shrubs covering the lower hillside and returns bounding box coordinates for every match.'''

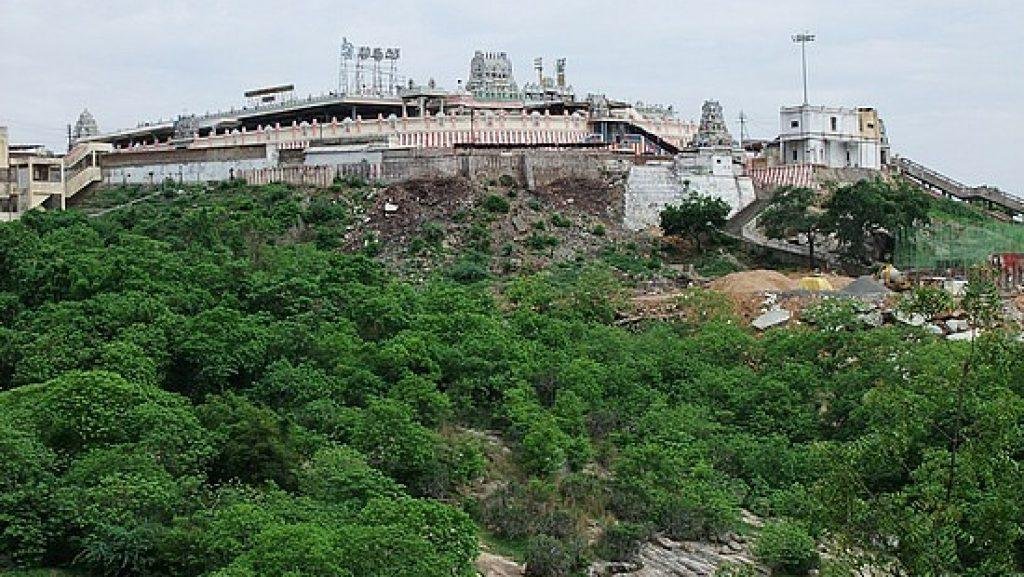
[0,182,1024,577]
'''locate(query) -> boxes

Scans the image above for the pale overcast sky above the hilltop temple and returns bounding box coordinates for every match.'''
[0,0,1024,195]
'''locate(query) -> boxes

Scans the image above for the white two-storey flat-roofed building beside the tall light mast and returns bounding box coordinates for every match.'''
[778,106,888,170]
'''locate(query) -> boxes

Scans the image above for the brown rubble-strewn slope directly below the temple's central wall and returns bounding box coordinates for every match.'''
[346,177,649,277]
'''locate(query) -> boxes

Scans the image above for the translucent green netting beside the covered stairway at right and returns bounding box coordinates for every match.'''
[893,221,1024,271]
